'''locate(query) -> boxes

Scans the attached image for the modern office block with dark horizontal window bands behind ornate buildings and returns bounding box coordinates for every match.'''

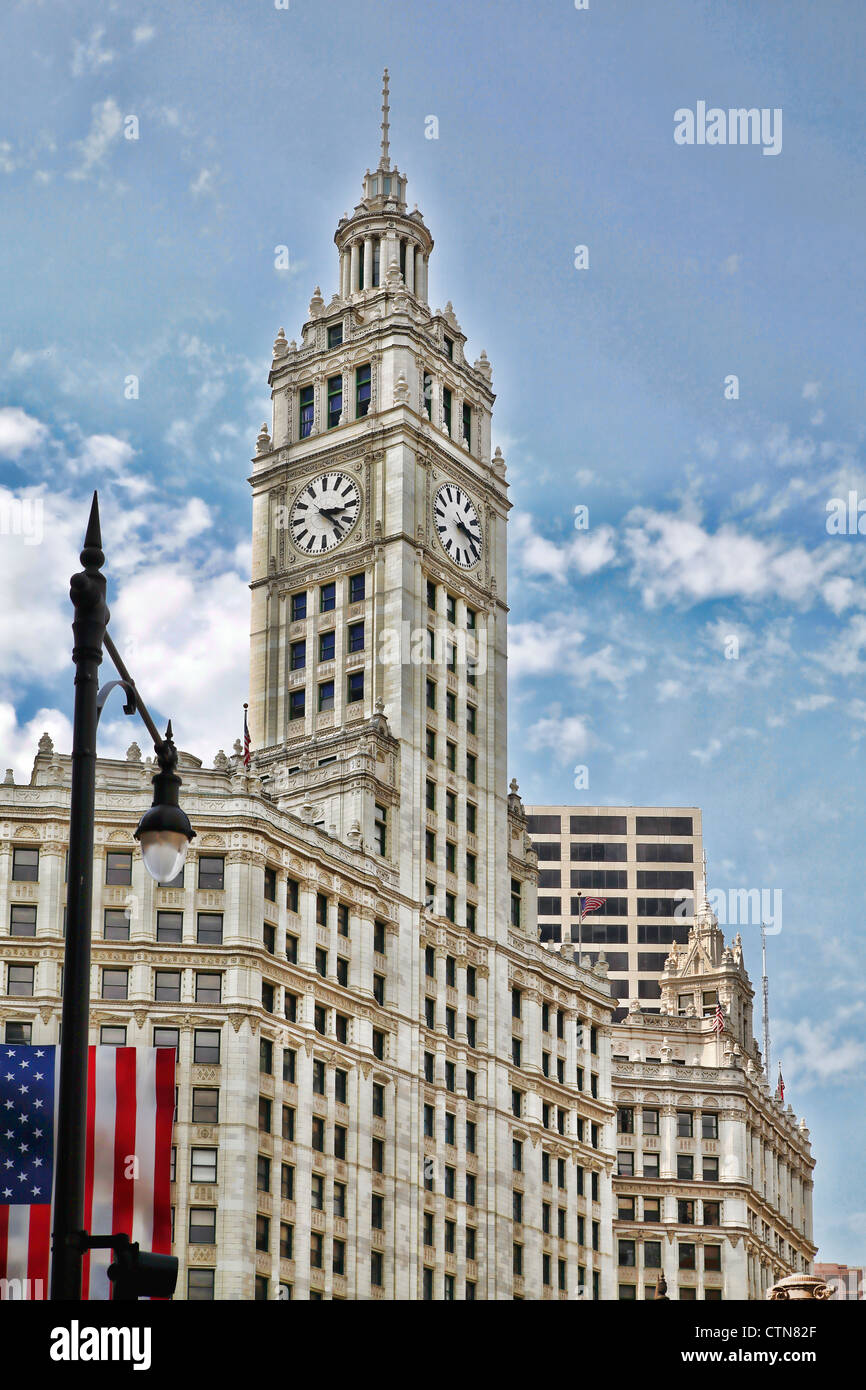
[527,806,703,1022]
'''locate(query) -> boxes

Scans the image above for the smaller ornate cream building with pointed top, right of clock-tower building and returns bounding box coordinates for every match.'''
[613,895,815,1300]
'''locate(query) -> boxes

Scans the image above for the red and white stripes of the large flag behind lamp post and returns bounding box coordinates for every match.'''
[0,1047,175,1300]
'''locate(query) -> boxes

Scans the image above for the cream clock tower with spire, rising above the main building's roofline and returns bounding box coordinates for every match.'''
[250,71,509,938]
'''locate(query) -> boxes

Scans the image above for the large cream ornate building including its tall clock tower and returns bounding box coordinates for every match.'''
[0,85,614,1300]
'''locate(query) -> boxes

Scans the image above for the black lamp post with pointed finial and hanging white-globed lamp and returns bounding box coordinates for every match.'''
[51,492,195,1302]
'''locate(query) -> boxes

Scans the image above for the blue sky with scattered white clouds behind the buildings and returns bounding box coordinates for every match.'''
[0,0,866,1264]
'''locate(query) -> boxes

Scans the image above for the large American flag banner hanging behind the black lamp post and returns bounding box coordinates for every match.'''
[0,1044,175,1300]
